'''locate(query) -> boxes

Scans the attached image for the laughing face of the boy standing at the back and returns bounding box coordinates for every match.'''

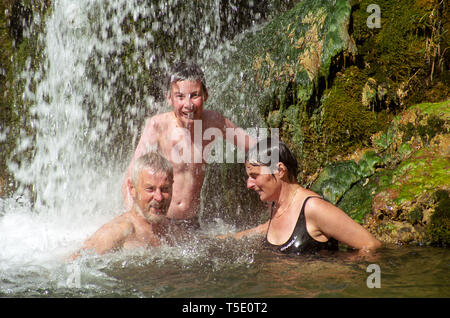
[166,80,208,127]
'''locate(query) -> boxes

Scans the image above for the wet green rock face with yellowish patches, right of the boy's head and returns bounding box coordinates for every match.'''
[211,0,356,129]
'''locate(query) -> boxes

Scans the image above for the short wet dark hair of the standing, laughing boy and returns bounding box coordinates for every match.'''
[165,61,206,94]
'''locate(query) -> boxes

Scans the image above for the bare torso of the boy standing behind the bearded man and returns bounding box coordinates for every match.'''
[123,111,250,219]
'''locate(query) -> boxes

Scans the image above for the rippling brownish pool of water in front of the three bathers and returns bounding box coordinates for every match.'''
[0,221,450,298]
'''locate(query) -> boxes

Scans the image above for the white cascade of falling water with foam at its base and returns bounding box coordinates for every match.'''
[0,0,137,286]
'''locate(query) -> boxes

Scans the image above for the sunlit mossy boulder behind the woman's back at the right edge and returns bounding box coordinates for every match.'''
[312,101,450,245]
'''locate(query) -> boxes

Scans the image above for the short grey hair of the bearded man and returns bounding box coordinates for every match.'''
[131,151,173,187]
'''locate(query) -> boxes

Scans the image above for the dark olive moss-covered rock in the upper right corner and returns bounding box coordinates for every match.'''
[299,0,449,173]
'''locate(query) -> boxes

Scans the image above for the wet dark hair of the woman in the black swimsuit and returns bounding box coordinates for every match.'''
[245,137,298,181]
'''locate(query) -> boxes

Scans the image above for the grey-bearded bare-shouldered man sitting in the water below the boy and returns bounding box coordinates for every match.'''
[72,152,173,259]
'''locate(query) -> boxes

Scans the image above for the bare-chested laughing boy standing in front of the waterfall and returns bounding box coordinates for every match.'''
[122,62,253,220]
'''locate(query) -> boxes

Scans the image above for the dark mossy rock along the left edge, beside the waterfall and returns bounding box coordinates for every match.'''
[0,0,51,192]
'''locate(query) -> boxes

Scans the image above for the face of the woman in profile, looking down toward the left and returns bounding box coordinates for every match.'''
[245,161,281,202]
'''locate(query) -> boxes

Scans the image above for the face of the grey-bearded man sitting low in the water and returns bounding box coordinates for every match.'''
[131,168,173,221]
